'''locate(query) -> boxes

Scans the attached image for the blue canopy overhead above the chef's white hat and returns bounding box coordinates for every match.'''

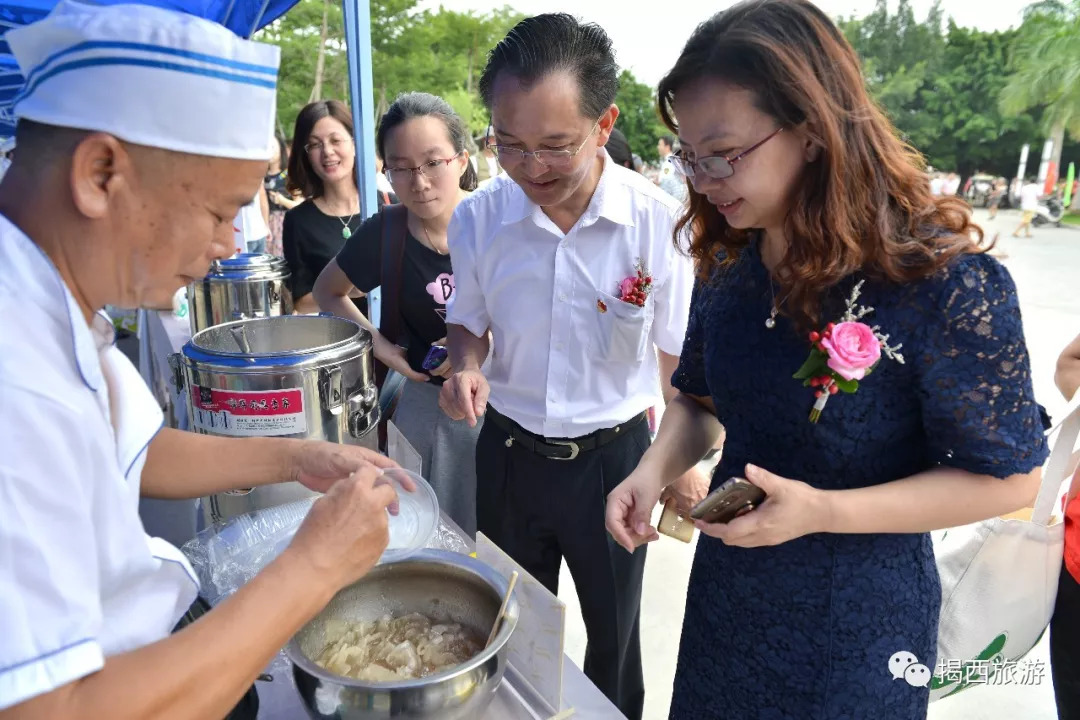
[0,0,299,139]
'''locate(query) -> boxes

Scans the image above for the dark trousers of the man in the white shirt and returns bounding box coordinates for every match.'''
[476,407,649,720]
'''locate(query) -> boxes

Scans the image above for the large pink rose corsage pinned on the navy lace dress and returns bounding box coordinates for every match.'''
[793,281,904,422]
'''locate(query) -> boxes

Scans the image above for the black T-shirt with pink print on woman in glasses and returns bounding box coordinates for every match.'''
[337,213,454,382]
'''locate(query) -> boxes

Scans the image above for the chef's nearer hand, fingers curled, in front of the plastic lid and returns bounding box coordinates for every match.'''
[285,465,416,593]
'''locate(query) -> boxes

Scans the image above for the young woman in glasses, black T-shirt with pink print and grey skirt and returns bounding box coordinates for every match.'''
[313,93,480,535]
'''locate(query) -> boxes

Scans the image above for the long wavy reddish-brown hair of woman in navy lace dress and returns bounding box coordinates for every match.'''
[658,0,984,327]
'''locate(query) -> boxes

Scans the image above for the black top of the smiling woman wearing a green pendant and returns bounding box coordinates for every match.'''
[281,200,367,316]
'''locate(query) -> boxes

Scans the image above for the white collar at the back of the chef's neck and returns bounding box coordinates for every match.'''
[0,215,108,391]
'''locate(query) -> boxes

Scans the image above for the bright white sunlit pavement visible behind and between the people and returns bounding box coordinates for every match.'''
[559,210,1080,720]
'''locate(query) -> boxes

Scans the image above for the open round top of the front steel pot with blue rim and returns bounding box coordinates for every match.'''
[184,315,372,367]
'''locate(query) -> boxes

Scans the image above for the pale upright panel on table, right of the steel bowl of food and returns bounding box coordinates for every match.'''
[476,532,566,709]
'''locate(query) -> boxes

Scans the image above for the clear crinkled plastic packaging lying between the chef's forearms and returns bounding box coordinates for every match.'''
[180,498,315,606]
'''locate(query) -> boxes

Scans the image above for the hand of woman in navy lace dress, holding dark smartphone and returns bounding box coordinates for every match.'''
[693,465,829,547]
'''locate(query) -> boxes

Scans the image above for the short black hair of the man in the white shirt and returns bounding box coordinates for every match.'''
[480,13,619,119]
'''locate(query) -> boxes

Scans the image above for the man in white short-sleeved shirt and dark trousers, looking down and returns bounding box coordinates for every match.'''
[441,14,707,720]
